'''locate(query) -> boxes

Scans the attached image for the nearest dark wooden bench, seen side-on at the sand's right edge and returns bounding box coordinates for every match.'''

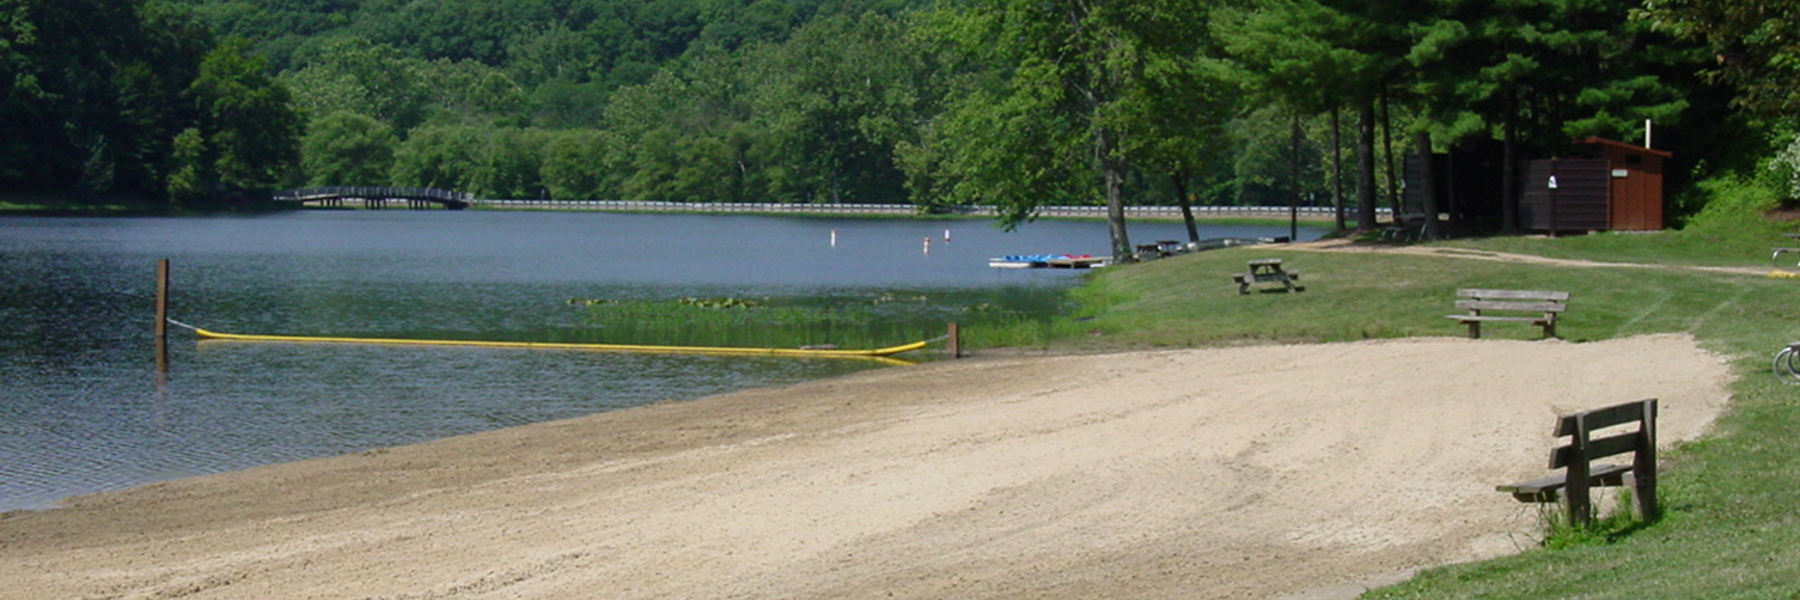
[1496,398,1656,524]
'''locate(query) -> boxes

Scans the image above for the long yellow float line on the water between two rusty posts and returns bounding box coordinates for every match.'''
[167,319,932,360]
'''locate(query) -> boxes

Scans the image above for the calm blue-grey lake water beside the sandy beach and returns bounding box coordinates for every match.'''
[0,211,1321,510]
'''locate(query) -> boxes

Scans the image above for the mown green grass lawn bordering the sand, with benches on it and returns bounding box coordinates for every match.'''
[1008,227,1800,598]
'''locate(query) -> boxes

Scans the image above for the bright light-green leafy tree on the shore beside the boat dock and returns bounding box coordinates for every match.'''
[927,0,1208,259]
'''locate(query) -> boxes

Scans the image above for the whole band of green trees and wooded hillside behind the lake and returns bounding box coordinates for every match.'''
[0,0,1800,234]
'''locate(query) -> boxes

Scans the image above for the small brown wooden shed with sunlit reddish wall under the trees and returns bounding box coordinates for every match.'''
[1519,137,1672,232]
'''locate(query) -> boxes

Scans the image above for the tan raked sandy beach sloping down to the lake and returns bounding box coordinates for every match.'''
[0,335,1730,600]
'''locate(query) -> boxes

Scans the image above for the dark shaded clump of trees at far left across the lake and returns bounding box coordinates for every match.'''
[0,0,302,202]
